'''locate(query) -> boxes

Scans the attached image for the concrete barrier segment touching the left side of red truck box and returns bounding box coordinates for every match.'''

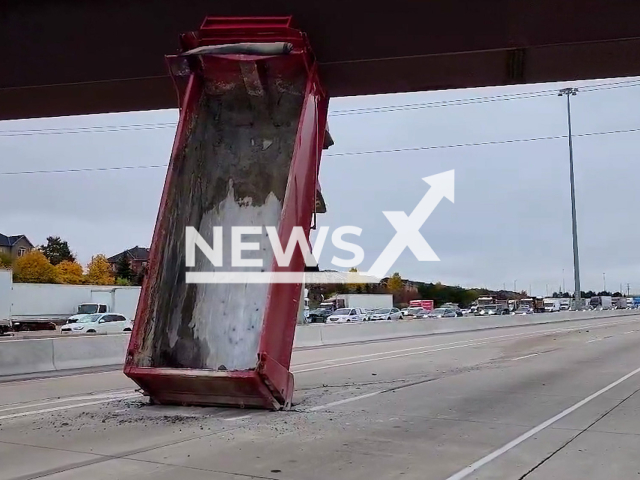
[54,334,129,370]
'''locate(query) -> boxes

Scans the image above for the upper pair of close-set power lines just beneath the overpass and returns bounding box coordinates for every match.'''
[0,79,640,137]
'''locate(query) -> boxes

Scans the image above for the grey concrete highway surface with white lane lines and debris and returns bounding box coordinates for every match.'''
[0,316,640,480]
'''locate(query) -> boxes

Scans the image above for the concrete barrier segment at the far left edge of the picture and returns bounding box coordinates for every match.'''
[0,338,55,375]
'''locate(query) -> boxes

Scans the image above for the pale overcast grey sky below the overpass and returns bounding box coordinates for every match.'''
[0,79,640,295]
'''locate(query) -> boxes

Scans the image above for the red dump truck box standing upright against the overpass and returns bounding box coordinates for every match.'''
[125,17,332,409]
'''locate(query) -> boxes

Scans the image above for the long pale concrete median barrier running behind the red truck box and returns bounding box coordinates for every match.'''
[0,310,640,376]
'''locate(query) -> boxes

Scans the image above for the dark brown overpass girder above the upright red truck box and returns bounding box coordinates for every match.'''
[0,0,640,120]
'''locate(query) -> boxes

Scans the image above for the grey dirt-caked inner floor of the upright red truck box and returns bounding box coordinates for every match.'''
[134,62,306,370]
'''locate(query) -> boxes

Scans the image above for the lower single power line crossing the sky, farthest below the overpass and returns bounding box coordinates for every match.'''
[5,128,640,176]
